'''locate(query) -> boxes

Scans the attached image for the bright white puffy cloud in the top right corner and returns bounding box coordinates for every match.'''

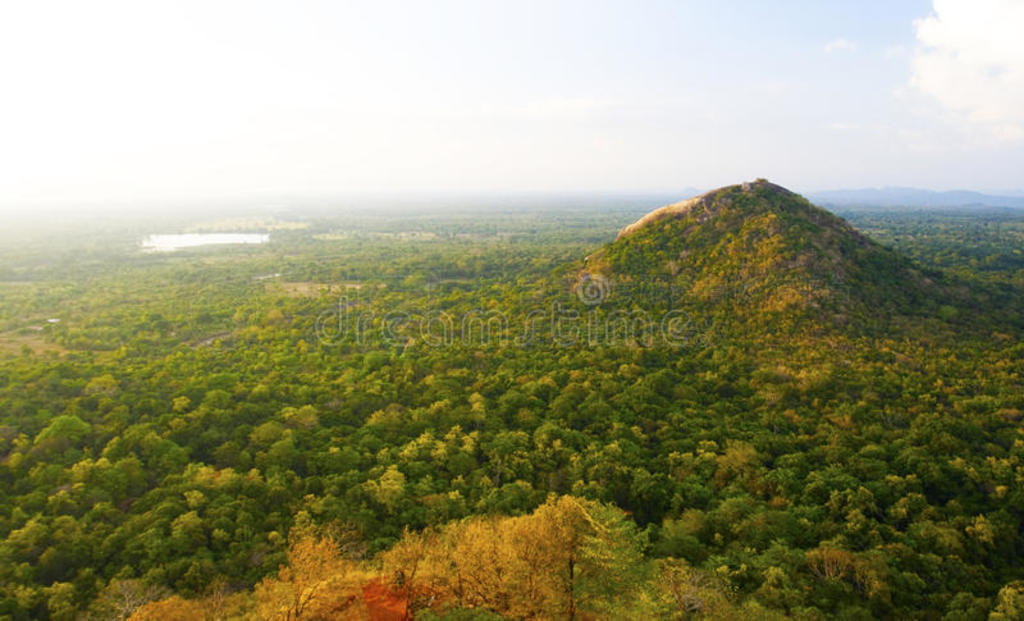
[910,0,1024,142]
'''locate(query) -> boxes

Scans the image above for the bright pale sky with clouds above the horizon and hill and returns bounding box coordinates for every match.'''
[0,0,1024,209]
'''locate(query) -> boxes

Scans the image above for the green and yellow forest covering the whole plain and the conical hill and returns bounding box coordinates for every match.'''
[0,192,1024,620]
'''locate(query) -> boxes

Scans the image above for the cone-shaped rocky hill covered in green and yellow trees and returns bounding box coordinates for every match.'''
[580,179,947,334]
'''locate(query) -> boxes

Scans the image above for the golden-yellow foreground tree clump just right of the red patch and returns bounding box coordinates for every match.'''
[382,496,645,619]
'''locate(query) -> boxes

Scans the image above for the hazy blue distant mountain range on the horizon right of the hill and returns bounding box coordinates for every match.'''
[807,188,1024,209]
